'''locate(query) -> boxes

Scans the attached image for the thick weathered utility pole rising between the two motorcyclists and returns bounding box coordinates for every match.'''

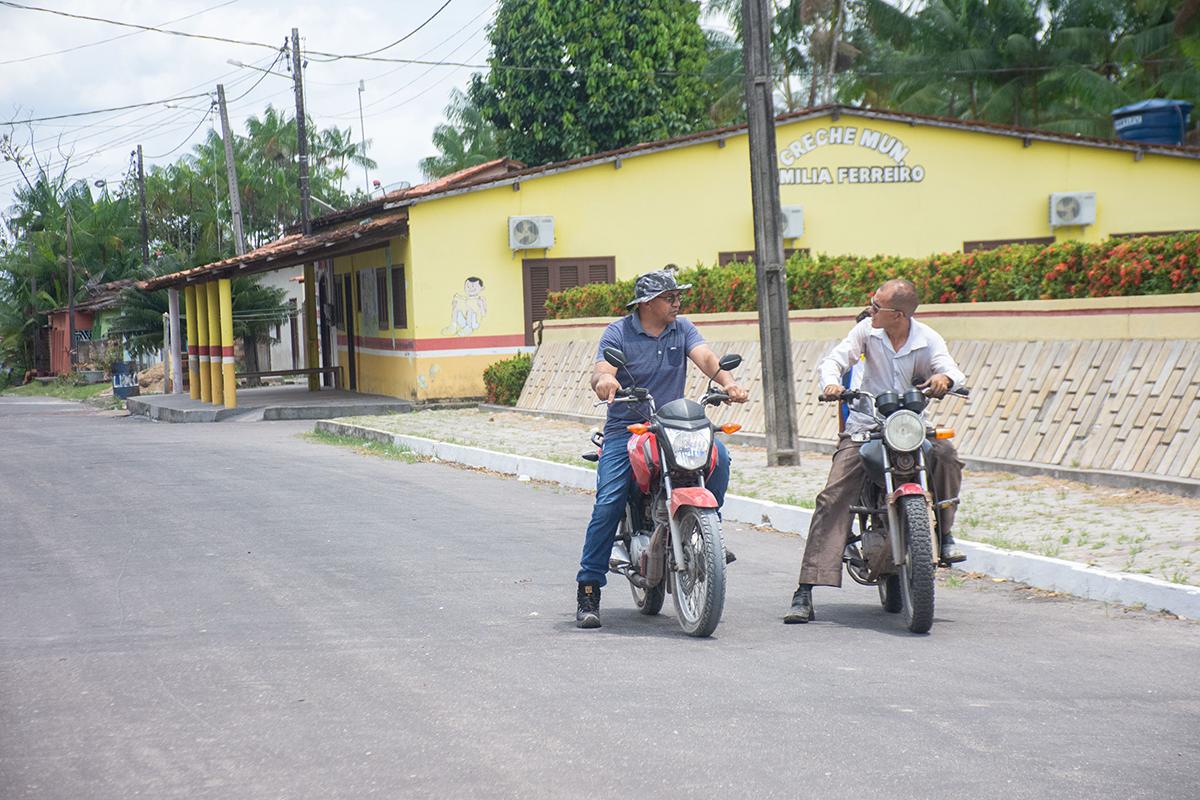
[742,0,800,467]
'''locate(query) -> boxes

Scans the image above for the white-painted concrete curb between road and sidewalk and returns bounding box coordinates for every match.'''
[316,420,1200,619]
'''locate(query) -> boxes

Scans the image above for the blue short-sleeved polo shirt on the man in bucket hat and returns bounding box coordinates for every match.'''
[596,313,704,435]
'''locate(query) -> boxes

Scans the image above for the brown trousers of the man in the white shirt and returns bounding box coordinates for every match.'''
[800,434,962,587]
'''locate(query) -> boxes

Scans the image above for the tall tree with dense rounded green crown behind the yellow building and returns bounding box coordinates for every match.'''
[470,0,709,164]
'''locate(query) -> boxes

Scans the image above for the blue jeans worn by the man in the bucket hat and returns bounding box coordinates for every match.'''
[575,431,730,587]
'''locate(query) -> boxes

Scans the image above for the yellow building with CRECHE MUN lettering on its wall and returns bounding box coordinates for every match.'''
[142,107,1200,401]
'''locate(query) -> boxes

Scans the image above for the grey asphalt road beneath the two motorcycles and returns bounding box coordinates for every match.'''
[0,398,1200,800]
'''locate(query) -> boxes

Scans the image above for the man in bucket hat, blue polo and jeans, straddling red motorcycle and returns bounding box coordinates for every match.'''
[575,266,749,627]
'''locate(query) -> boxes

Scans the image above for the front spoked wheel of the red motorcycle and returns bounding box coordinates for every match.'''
[671,507,725,637]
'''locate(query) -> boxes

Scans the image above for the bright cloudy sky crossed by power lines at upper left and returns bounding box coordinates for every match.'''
[0,0,497,210]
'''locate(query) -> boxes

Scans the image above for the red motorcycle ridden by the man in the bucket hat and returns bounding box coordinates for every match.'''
[583,348,742,637]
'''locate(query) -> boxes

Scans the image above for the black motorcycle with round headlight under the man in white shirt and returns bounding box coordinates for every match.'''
[820,387,970,633]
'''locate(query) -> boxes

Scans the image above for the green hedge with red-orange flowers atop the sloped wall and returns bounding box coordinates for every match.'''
[546,234,1200,319]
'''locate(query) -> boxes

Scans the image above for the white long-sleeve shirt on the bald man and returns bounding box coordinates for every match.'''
[817,318,967,433]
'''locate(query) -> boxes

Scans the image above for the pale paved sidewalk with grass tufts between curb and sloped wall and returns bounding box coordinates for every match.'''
[342,409,1200,585]
